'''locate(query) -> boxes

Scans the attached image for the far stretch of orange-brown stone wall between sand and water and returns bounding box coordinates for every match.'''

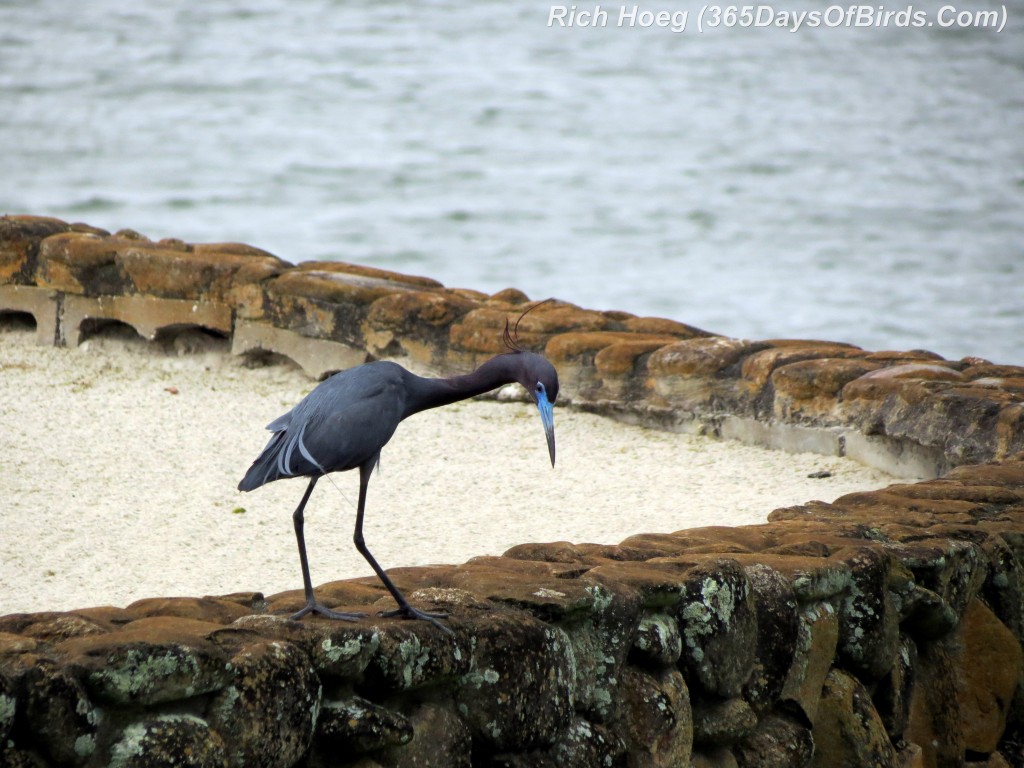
[8,216,1024,473]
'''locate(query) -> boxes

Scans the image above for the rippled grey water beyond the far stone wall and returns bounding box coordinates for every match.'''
[0,0,1024,364]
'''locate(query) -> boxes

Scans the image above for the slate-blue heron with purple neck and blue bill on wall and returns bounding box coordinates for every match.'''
[239,311,558,633]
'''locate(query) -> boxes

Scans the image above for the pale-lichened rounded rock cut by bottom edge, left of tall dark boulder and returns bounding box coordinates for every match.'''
[106,715,230,768]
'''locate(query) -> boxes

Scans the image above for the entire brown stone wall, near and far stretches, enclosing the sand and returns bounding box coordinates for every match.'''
[0,216,1024,768]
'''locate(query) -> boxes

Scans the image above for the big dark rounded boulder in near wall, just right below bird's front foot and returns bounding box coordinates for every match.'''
[456,611,575,752]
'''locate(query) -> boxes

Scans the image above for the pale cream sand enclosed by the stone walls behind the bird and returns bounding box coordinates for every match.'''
[0,324,909,614]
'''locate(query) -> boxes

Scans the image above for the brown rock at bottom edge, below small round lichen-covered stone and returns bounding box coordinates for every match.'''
[618,667,693,768]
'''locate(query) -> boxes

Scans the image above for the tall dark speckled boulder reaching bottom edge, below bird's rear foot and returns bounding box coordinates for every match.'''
[207,641,322,768]
